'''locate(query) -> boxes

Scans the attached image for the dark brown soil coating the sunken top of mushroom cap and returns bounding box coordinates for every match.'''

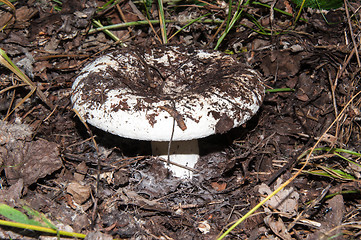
[76,45,260,105]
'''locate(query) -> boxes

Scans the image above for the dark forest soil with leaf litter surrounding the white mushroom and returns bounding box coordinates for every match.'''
[0,0,361,239]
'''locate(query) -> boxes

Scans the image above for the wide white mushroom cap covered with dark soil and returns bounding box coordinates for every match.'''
[71,45,264,141]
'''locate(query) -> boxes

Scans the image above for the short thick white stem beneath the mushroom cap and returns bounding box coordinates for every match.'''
[152,139,199,178]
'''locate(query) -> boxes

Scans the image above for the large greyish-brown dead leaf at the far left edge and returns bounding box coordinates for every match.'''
[0,122,62,186]
